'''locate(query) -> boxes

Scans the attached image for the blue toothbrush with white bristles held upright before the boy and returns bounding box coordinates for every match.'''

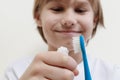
[73,35,92,80]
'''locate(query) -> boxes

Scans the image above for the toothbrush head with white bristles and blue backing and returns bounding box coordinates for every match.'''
[72,35,84,53]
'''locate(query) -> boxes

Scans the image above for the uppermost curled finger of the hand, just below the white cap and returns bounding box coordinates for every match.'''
[36,51,77,71]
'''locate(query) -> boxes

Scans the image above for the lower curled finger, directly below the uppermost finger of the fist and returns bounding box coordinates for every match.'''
[40,64,74,80]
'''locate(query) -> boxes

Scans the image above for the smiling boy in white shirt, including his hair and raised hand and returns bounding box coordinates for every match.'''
[3,0,120,80]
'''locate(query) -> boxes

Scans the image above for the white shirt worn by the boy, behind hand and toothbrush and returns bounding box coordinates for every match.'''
[2,56,120,80]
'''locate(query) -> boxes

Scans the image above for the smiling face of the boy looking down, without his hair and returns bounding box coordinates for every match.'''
[37,0,95,50]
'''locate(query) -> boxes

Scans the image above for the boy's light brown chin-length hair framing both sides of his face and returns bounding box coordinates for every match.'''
[33,0,104,43]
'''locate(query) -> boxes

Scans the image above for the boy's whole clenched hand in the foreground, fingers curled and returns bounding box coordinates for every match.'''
[20,51,78,80]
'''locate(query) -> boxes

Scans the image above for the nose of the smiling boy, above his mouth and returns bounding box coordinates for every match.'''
[61,11,77,27]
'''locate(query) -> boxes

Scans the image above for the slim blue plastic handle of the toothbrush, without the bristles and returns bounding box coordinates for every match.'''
[80,36,92,80]
